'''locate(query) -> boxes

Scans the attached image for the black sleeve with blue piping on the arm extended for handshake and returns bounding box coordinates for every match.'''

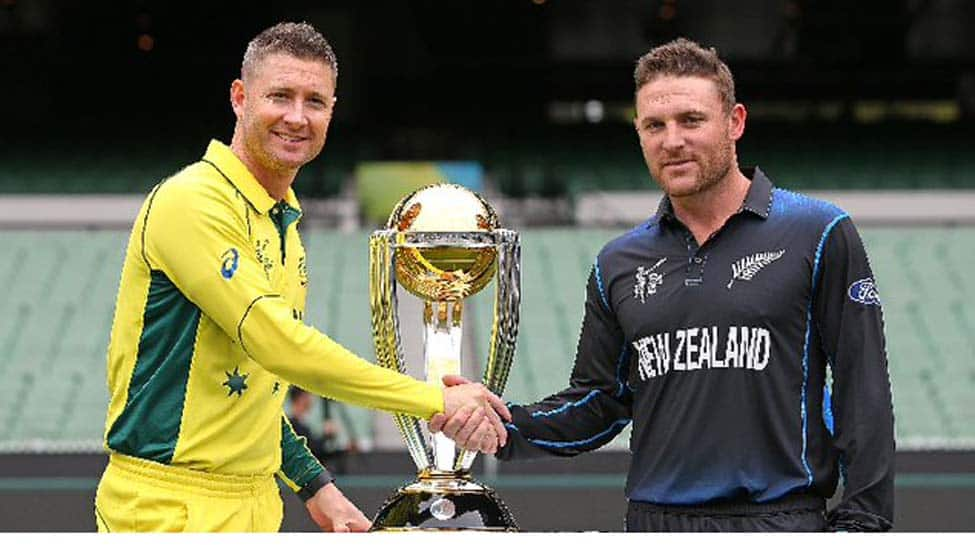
[498,269,632,460]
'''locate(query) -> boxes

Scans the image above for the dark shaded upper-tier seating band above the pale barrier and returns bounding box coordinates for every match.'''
[0,123,975,197]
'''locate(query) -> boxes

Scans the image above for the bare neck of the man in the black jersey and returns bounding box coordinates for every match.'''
[670,167,751,245]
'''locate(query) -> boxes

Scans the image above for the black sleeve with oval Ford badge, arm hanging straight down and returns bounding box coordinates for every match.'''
[814,218,894,530]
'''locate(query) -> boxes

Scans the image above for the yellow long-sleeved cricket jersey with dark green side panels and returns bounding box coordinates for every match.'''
[105,141,443,490]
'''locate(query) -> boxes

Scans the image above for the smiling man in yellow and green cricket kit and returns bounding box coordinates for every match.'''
[95,23,510,532]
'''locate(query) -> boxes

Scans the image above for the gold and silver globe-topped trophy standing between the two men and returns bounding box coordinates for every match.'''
[369,184,521,531]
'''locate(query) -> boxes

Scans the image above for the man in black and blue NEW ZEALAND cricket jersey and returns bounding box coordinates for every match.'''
[430,38,894,532]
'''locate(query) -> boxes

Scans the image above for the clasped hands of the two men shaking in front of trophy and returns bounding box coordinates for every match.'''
[430,375,511,454]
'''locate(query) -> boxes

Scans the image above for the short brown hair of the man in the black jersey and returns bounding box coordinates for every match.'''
[633,38,735,111]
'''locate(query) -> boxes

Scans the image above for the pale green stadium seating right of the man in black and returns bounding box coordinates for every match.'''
[863,228,975,445]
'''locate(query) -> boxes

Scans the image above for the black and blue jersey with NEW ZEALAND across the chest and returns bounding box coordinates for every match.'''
[499,168,894,529]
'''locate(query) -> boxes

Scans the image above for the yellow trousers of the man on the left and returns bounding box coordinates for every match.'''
[95,453,284,532]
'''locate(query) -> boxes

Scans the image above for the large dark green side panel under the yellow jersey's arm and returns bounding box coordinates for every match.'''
[108,271,201,464]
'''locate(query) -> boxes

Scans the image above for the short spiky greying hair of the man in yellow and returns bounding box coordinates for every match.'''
[240,22,339,79]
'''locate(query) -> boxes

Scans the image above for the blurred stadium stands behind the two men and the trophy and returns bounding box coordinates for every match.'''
[0,0,975,531]
